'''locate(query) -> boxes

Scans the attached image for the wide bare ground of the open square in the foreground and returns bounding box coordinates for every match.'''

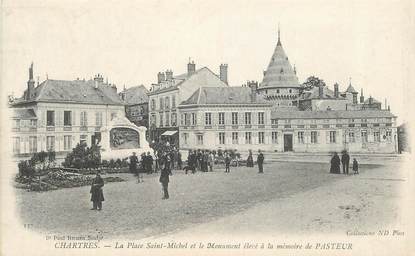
[17,158,405,239]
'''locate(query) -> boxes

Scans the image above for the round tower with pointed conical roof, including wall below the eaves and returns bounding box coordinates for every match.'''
[258,27,301,108]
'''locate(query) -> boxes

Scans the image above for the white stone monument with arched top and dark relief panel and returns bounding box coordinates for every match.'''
[100,116,153,160]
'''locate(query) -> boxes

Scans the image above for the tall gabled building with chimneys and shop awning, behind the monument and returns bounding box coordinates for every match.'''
[149,62,228,145]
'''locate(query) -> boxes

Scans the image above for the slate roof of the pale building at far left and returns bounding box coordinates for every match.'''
[15,79,124,105]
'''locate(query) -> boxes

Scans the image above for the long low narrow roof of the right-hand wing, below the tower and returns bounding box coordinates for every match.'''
[271,110,396,119]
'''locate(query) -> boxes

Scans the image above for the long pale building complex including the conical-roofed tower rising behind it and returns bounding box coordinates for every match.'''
[179,31,397,153]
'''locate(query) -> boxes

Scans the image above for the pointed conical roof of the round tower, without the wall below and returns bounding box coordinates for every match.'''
[260,31,300,88]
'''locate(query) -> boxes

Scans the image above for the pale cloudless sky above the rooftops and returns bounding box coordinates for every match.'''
[1,0,415,122]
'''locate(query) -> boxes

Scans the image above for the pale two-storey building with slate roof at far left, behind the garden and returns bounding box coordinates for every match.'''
[10,64,125,159]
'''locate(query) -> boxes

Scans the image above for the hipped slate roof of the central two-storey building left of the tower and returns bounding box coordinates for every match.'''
[180,86,271,105]
